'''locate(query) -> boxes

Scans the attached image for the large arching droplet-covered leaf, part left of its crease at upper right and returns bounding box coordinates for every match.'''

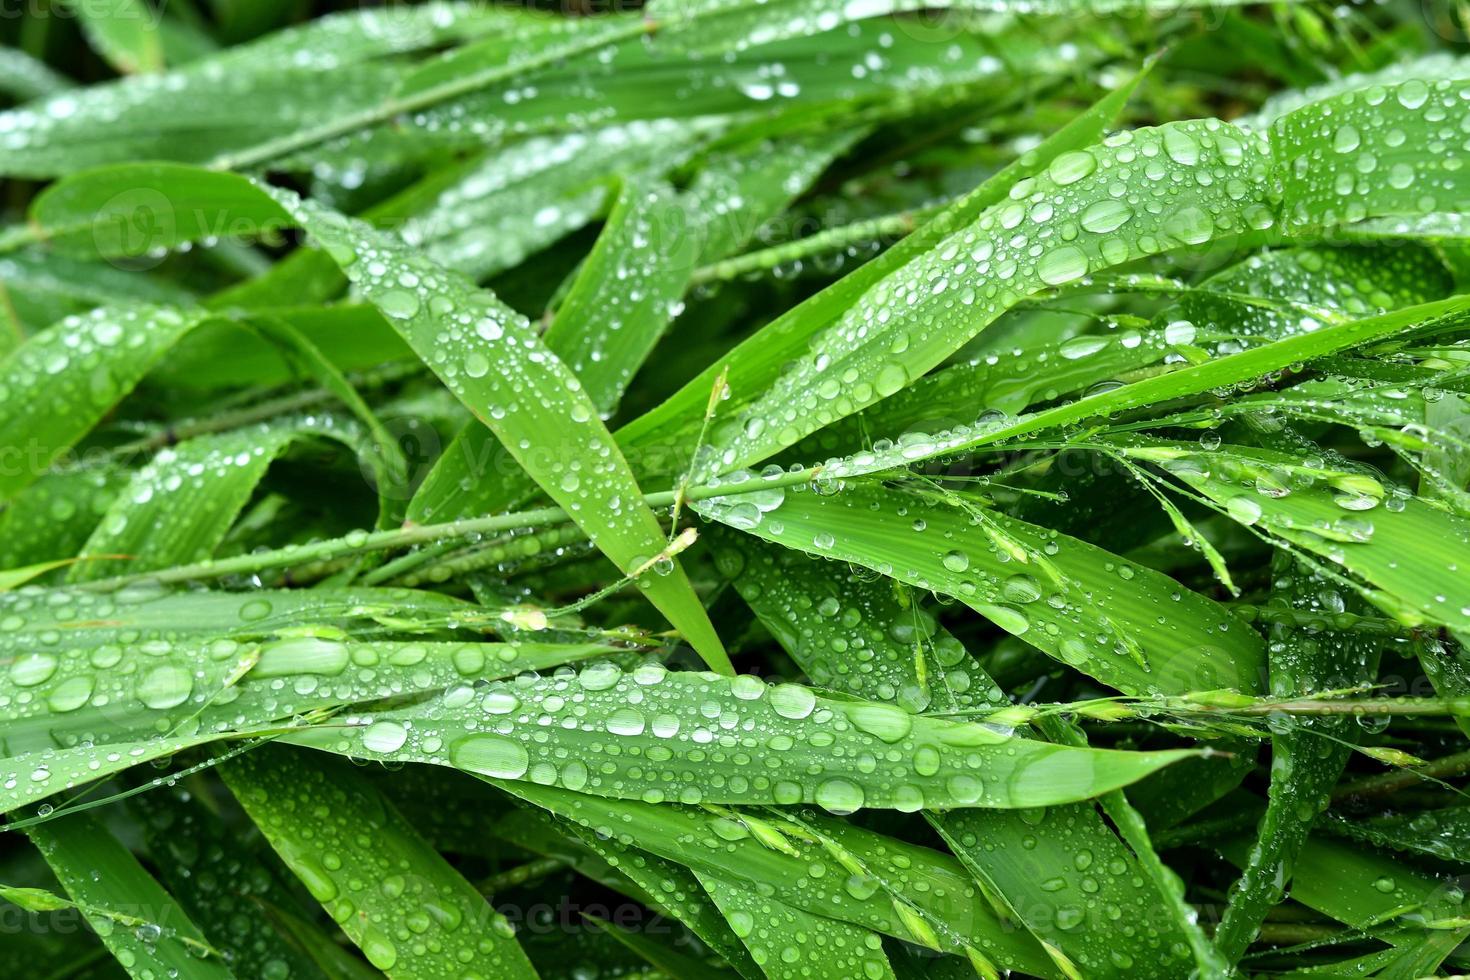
[699,120,1273,467]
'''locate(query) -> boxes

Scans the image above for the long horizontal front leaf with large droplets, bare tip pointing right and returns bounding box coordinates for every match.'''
[288,663,1188,813]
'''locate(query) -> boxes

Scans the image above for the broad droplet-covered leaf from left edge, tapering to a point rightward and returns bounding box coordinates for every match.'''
[0,589,613,758]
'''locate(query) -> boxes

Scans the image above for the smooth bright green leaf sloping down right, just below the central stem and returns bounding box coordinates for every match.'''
[694,478,1264,693]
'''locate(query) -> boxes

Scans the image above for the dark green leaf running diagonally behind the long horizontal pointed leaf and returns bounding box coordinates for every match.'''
[720,532,1194,976]
